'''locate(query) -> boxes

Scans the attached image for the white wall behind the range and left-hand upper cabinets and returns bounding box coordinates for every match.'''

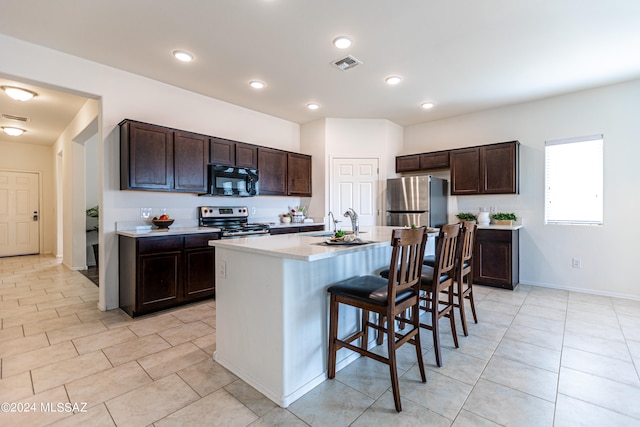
[0,31,300,309]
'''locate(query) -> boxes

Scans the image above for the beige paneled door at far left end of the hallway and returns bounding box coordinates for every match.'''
[0,171,40,256]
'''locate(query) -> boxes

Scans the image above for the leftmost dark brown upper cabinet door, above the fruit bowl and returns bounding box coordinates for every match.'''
[120,121,173,191]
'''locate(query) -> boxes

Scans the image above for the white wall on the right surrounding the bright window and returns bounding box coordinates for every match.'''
[403,81,640,299]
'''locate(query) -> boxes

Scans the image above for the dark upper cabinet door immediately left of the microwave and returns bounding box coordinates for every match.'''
[173,132,209,193]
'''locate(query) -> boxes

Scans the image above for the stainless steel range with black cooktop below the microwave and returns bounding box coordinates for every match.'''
[198,206,269,239]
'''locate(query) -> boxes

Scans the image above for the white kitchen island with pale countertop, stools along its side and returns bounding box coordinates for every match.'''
[209,227,435,407]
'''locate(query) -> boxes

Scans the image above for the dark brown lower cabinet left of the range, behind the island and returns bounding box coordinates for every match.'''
[119,233,220,317]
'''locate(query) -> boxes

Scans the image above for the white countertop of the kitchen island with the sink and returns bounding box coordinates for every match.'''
[209,227,436,261]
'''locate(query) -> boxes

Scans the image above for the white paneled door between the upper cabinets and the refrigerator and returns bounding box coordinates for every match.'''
[331,158,379,228]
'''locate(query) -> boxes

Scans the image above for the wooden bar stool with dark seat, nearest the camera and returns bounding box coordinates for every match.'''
[327,227,427,412]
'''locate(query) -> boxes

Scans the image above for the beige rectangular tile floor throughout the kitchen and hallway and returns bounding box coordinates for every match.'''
[0,256,640,427]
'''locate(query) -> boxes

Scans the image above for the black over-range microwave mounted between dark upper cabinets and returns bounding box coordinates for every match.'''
[200,164,258,197]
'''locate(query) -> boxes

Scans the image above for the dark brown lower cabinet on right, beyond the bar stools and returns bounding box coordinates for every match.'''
[473,229,520,289]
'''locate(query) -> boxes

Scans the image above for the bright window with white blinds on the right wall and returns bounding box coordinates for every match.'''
[544,135,604,225]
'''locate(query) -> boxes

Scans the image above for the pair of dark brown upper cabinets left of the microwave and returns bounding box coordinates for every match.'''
[120,120,209,193]
